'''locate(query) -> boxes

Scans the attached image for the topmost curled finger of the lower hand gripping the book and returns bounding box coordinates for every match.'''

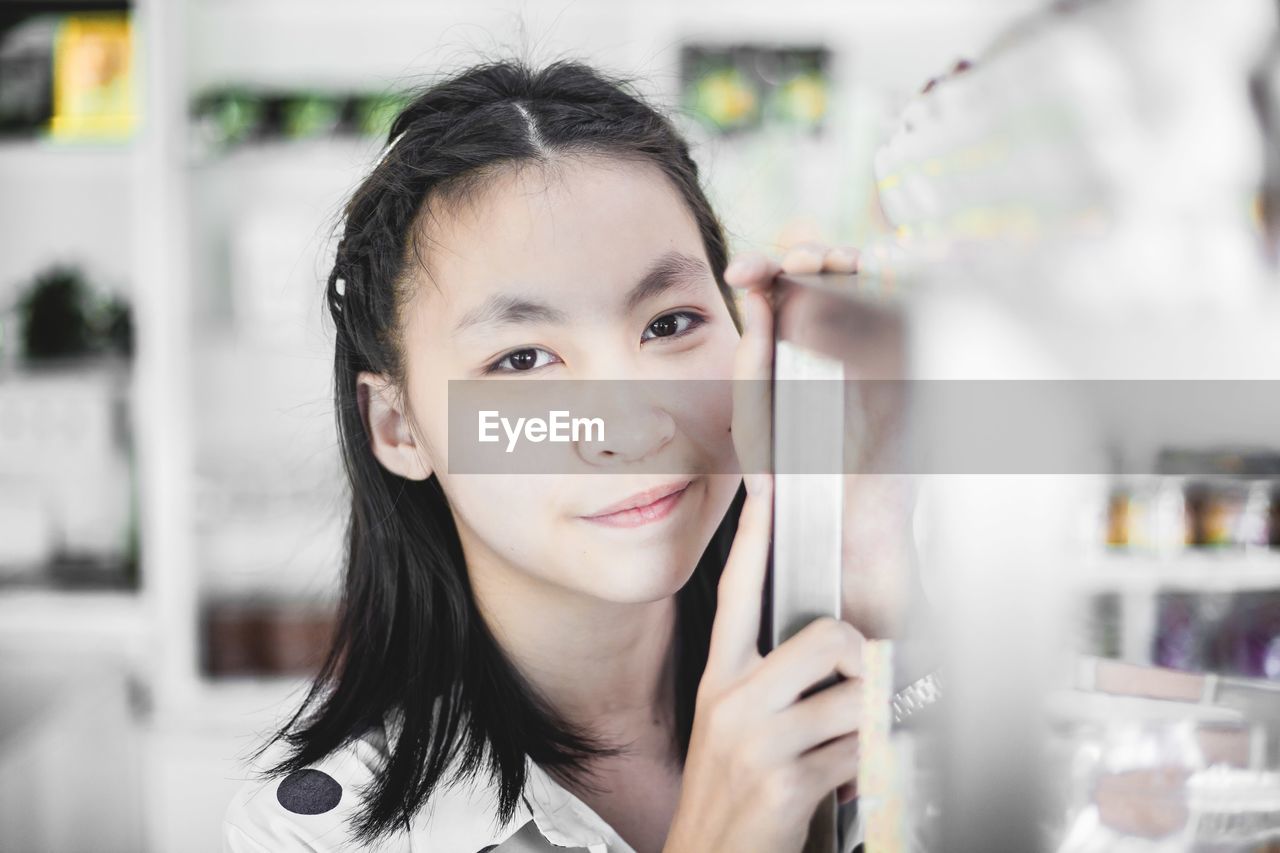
[753,616,867,711]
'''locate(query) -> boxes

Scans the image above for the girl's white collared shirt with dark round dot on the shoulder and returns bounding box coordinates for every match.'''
[223,712,861,853]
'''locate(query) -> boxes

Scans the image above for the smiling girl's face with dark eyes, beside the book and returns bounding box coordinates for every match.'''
[375,156,740,602]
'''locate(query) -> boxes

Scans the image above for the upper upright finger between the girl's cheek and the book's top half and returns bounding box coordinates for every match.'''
[730,292,773,481]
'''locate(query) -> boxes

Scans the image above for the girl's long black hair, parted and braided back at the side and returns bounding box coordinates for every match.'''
[259,60,745,840]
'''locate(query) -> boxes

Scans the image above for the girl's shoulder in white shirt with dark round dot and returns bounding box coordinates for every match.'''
[223,726,527,853]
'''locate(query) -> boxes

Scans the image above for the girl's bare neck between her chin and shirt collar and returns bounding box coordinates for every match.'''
[468,537,676,758]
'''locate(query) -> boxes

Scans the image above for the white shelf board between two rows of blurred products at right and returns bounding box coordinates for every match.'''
[1069,551,1280,593]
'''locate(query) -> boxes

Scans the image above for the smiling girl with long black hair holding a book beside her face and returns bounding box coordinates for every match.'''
[224,61,861,853]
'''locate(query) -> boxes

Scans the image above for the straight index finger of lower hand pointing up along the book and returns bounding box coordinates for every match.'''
[703,468,773,683]
